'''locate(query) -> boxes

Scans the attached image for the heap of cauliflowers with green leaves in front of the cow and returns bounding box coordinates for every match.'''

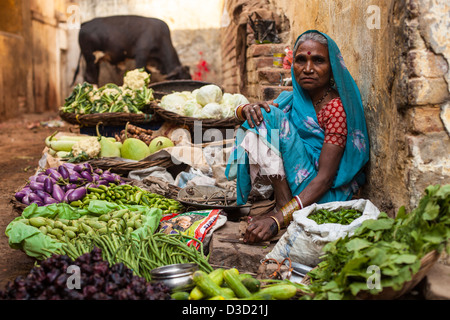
[61,69,154,114]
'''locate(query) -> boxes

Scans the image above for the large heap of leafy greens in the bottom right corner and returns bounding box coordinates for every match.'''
[308,185,450,299]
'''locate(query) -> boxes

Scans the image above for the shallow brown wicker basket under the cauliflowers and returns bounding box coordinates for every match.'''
[59,101,157,127]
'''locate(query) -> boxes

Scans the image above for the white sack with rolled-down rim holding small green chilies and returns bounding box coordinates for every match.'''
[265,199,380,268]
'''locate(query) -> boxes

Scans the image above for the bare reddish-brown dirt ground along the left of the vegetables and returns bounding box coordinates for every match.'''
[0,112,77,290]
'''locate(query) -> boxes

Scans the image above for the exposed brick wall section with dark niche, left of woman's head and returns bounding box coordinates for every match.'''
[221,0,290,101]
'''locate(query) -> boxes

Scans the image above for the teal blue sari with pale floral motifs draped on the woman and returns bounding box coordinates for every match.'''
[225,30,369,205]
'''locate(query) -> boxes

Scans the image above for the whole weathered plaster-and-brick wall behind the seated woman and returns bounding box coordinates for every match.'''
[222,0,450,215]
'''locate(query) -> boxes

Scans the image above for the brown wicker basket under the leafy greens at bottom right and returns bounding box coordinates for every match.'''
[302,250,439,300]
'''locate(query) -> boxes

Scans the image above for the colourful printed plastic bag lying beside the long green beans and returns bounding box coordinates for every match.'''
[160,209,227,249]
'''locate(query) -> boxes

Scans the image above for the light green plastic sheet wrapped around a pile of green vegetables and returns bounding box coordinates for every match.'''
[5,200,162,260]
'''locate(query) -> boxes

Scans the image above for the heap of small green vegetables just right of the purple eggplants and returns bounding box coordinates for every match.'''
[79,184,183,215]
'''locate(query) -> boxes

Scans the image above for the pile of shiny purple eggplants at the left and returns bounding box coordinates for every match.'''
[14,163,125,206]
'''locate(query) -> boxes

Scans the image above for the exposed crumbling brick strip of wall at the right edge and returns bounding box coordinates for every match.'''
[405,0,450,206]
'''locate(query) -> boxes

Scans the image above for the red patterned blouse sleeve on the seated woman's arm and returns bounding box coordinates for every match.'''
[317,98,347,148]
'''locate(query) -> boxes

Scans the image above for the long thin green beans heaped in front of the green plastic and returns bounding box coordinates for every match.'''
[62,228,213,281]
